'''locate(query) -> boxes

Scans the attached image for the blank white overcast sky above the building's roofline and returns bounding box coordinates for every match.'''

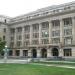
[0,0,75,17]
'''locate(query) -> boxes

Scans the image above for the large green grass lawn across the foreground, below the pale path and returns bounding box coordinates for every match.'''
[0,64,75,75]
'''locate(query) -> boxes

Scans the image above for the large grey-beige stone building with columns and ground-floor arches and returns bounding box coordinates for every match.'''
[0,2,75,58]
